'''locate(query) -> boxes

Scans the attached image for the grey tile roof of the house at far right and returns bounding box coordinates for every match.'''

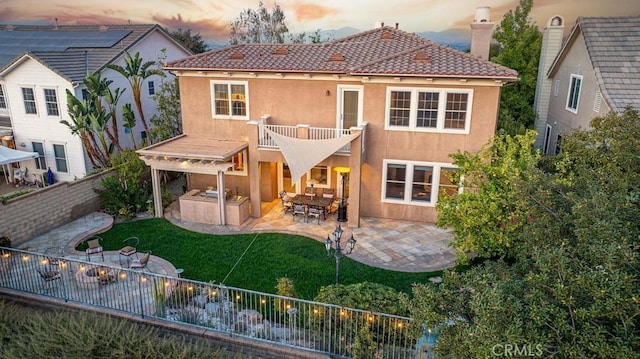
[563,16,640,112]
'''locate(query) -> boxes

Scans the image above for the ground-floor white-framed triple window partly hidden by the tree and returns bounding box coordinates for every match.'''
[382,160,459,206]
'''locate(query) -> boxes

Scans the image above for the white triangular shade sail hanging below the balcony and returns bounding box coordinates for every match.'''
[265,128,360,183]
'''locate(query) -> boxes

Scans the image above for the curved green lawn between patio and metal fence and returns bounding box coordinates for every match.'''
[79,218,441,299]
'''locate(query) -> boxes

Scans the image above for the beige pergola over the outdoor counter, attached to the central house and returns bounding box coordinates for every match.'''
[136,135,249,225]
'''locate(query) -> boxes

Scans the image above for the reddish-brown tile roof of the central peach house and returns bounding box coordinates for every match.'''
[165,27,518,81]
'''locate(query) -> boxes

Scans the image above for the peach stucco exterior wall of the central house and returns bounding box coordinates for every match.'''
[180,74,500,222]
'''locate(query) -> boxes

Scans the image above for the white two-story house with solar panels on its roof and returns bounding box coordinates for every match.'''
[0,25,191,181]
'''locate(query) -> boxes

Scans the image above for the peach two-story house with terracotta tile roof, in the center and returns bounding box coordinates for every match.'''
[138,7,517,226]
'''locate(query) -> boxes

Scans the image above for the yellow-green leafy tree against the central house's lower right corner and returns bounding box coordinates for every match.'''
[436,131,539,263]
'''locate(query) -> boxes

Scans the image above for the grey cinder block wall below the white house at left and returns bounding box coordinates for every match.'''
[0,170,115,247]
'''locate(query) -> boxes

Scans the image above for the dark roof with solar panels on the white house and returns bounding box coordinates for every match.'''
[0,24,175,82]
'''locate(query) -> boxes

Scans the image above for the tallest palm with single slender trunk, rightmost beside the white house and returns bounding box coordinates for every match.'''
[107,52,164,142]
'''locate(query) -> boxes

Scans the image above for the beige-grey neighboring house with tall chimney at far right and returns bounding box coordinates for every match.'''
[536,16,640,155]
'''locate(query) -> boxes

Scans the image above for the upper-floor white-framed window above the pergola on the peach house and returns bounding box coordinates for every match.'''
[211,81,248,119]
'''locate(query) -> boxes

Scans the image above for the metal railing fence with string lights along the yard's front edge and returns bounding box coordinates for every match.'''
[0,247,424,358]
